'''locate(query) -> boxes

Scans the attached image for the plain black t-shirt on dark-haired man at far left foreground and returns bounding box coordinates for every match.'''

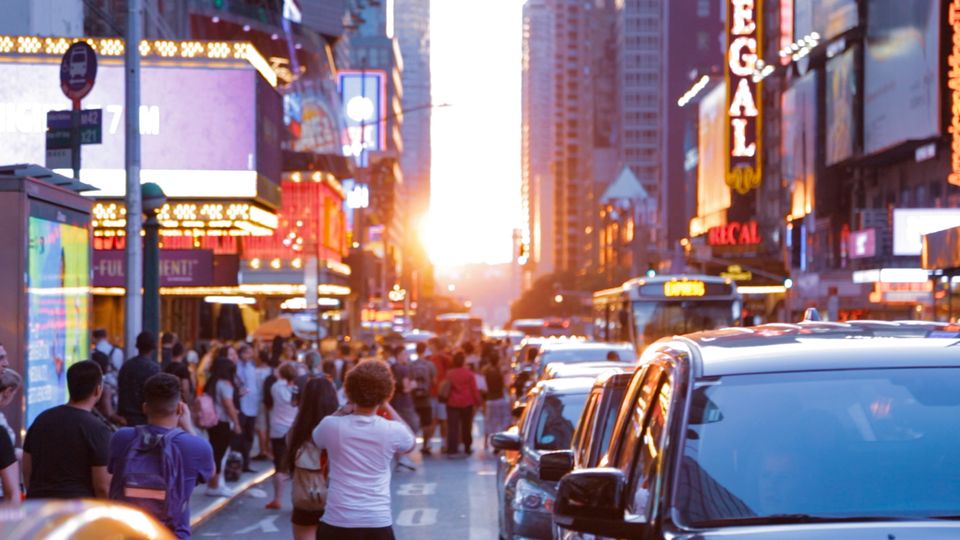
[23,405,113,499]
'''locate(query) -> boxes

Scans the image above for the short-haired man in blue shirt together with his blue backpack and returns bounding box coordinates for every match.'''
[108,373,215,539]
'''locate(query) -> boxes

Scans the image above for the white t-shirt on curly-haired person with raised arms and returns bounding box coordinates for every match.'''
[313,414,416,528]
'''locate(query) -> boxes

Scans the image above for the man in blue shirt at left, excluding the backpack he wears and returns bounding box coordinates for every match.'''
[107,373,214,539]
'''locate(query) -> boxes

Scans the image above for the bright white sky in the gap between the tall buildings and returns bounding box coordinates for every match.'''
[424,0,523,267]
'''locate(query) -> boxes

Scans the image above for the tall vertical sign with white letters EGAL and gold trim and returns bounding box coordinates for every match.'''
[726,0,764,194]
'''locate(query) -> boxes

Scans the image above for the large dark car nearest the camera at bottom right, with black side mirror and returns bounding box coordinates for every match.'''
[554,321,960,540]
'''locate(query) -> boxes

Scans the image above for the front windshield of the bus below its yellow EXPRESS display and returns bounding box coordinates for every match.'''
[633,300,736,345]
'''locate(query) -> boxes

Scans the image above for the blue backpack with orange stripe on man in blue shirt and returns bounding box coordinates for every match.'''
[110,426,190,530]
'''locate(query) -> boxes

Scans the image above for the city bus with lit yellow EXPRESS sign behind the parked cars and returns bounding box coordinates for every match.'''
[593,275,741,352]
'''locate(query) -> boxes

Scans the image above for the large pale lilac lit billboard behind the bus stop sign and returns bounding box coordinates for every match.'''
[0,62,274,197]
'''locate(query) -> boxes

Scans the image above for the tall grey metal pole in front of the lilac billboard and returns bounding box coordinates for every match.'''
[123,0,143,355]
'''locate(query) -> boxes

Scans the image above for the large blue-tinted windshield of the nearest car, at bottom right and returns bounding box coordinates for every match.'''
[677,368,960,526]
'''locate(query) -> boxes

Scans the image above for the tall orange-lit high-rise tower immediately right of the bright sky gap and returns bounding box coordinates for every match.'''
[521,0,616,284]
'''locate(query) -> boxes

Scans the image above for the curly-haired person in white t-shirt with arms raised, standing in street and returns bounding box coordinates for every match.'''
[313,360,417,540]
